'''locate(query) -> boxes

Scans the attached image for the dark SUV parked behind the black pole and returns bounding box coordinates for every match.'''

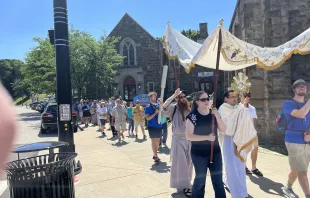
[41,103,78,134]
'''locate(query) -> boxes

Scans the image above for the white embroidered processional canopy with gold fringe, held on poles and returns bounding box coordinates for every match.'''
[164,23,310,72]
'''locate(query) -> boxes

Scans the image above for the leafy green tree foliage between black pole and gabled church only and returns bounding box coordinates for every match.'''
[70,28,123,99]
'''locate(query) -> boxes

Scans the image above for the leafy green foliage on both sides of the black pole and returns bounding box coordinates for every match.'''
[16,27,123,98]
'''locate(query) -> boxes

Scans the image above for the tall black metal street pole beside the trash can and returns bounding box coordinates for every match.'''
[53,0,75,152]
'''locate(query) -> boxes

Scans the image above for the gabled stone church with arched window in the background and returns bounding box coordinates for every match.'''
[109,14,223,101]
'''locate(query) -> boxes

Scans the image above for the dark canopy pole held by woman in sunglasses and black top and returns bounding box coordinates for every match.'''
[210,25,222,163]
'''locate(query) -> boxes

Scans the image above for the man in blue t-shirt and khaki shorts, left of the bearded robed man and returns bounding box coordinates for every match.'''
[144,92,162,163]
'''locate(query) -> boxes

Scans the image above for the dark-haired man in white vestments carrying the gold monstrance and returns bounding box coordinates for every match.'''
[219,90,252,198]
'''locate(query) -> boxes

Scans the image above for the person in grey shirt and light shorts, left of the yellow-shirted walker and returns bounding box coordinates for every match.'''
[112,99,128,142]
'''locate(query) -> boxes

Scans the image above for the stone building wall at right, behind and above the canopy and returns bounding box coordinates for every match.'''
[228,0,310,144]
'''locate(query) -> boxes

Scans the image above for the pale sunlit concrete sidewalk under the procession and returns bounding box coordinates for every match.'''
[75,127,303,198]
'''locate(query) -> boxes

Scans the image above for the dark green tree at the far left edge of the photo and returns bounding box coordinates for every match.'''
[0,59,26,97]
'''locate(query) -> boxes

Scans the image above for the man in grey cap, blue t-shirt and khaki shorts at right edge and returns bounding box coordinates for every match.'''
[282,79,310,198]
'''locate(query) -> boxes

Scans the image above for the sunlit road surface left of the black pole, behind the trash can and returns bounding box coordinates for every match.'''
[0,106,58,198]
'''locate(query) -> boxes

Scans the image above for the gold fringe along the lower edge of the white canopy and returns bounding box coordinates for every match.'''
[163,32,310,73]
